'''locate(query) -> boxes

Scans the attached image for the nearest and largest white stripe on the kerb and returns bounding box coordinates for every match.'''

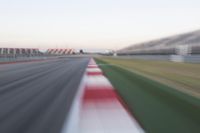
[79,100,144,133]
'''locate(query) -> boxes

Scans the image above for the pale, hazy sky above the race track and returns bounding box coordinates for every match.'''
[0,0,200,50]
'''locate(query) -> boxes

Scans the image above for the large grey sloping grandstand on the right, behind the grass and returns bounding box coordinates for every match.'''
[117,30,200,55]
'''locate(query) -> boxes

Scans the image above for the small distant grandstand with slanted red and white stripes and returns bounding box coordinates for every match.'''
[46,48,75,55]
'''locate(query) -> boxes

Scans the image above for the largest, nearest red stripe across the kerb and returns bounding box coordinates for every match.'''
[83,89,117,101]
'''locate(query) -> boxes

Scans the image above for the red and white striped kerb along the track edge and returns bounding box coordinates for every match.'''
[79,59,144,133]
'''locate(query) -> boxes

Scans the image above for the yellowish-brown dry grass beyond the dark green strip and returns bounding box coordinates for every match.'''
[96,57,200,97]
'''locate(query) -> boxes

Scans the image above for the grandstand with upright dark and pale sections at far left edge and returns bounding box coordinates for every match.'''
[0,48,42,57]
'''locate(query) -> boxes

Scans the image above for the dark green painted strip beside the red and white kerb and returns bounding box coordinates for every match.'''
[96,58,200,133]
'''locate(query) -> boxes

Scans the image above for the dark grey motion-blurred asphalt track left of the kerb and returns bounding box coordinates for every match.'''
[0,57,89,133]
